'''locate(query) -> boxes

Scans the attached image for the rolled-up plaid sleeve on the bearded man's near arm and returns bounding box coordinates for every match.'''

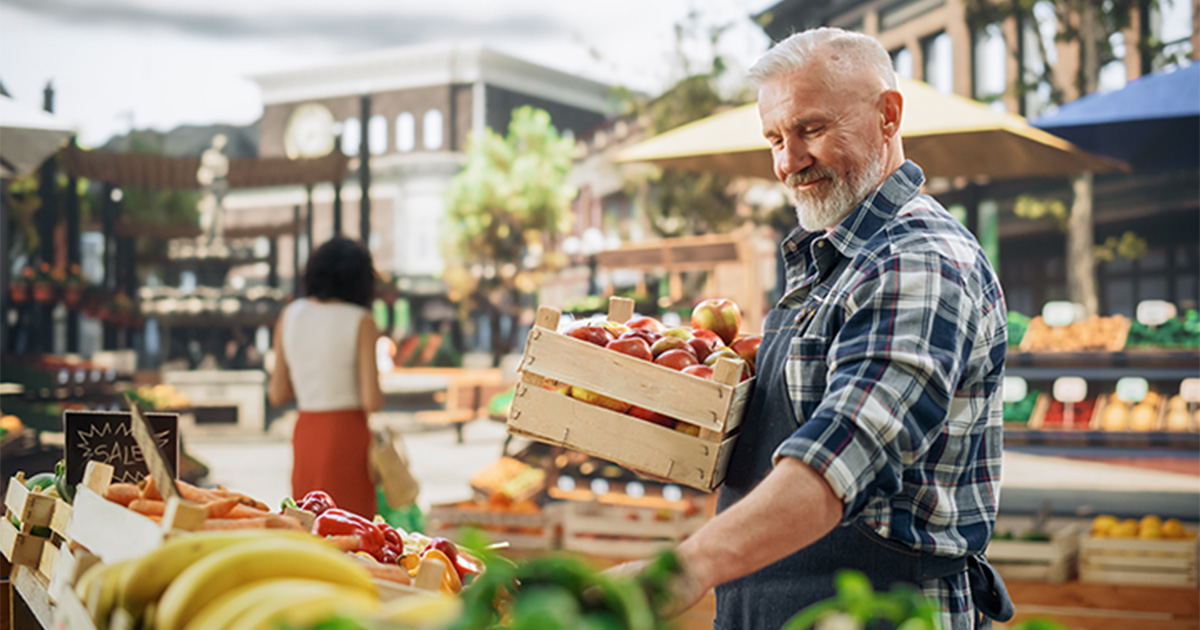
[774,253,977,520]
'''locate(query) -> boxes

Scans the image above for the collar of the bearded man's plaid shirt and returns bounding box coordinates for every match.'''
[781,160,925,270]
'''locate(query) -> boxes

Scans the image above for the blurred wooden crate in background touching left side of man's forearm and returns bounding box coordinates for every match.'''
[563,502,708,558]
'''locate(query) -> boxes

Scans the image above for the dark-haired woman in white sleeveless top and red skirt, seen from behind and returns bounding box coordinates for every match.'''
[268,238,383,518]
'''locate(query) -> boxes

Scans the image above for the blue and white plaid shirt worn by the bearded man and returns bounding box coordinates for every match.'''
[775,162,1007,629]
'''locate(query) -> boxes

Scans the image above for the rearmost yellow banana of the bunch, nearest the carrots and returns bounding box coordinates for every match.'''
[120,529,332,614]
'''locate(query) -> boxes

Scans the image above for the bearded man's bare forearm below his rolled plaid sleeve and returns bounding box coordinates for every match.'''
[677,457,845,611]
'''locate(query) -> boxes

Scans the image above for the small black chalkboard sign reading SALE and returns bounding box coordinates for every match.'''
[62,412,179,484]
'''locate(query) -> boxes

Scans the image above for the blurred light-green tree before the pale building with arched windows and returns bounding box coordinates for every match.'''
[446,107,575,365]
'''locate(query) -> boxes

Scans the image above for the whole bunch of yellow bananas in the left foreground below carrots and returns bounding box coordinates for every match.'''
[76,529,379,630]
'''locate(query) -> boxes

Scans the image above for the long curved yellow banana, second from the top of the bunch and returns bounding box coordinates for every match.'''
[155,538,378,630]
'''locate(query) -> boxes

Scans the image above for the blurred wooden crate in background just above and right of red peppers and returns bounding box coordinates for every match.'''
[426,502,562,551]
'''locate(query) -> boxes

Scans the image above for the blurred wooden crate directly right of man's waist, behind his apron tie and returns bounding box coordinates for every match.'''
[988,521,1079,584]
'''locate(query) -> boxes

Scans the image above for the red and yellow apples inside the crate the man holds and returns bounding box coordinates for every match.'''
[547,299,762,436]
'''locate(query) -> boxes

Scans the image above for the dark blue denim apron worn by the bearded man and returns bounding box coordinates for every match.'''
[713,259,1013,630]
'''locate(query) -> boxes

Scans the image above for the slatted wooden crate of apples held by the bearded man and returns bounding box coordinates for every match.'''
[508,299,754,491]
